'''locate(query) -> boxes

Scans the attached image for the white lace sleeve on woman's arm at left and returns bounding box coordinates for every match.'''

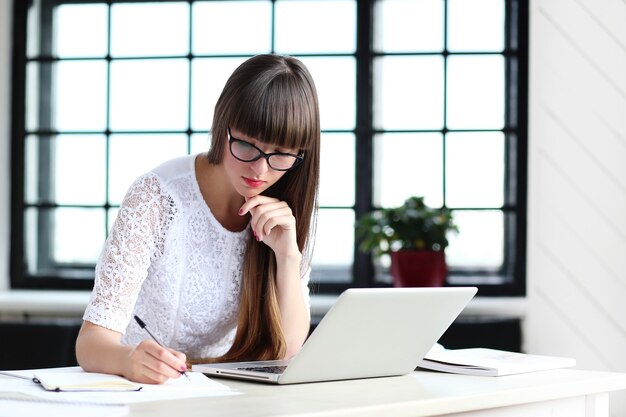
[83,175,175,333]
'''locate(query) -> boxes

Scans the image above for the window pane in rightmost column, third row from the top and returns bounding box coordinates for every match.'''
[446,132,504,207]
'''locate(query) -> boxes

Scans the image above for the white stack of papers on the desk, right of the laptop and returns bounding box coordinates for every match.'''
[418,348,576,376]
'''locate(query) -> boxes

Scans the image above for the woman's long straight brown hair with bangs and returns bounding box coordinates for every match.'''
[208,55,320,361]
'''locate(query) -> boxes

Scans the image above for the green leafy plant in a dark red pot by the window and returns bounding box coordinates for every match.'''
[356,197,458,287]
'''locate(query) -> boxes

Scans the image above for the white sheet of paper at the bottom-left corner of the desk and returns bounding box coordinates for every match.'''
[0,399,129,417]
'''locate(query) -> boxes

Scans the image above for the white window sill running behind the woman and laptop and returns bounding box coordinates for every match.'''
[0,290,527,320]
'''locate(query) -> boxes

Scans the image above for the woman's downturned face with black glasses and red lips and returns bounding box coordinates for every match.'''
[223,129,297,198]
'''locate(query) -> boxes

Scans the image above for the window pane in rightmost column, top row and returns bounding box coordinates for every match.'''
[448,0,504,51]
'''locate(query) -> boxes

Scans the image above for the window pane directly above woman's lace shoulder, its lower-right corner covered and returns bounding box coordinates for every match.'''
[109,134,187,205]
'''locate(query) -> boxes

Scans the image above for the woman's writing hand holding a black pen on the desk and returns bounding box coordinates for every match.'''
[131,340,187,384]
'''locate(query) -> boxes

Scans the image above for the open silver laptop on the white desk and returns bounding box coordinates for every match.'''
[192,287,477,384]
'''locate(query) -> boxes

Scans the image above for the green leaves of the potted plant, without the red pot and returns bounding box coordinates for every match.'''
[356,197,458,256]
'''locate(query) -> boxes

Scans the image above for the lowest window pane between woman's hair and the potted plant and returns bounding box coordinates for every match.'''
[313,209,354,281]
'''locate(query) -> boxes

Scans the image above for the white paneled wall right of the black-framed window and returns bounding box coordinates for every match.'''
[524,0,626,417]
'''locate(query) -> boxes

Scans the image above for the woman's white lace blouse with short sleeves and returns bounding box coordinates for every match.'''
[83,155,310,358]
